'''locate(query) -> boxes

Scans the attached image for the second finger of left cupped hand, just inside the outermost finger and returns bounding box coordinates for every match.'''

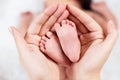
[40,4,66,35]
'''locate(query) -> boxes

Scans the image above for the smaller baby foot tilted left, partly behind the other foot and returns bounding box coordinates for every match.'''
[40,32,68,65]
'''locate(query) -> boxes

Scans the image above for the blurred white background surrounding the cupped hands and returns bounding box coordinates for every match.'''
[0,0,120,80]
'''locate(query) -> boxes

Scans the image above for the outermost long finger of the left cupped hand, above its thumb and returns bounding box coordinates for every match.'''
[28,5,58,35]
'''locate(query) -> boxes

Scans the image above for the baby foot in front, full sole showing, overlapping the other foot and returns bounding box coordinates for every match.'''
[54,20,80,62]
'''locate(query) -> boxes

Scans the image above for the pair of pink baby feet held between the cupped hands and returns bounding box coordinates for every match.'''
[40,20,81,64]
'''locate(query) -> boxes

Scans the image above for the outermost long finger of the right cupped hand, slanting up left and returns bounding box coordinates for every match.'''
[67,5,102,32]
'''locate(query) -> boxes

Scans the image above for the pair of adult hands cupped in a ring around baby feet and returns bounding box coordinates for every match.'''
[10,2,117,80]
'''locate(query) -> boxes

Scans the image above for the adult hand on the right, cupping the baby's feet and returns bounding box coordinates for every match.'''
[67,5,118,80]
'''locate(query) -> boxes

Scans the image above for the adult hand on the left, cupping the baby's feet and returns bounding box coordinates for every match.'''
[10,5,68,80]
